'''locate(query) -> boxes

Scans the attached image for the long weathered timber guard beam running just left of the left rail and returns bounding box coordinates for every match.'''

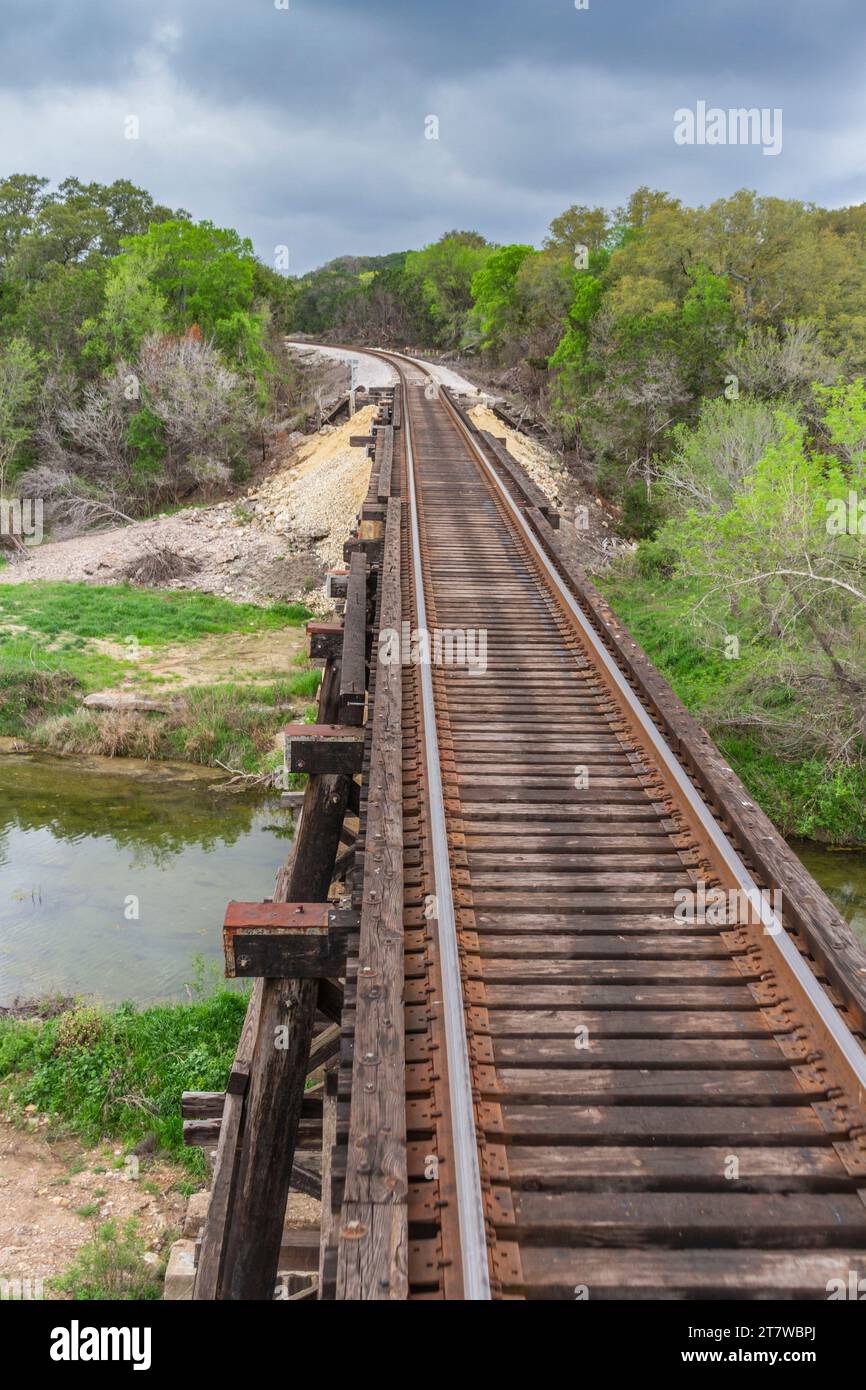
[336,499,409,1300]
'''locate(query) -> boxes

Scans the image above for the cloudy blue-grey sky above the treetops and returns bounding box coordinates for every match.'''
[0,0,866,274]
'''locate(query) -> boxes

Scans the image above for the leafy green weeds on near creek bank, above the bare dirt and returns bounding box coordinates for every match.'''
[0,987,246,1175]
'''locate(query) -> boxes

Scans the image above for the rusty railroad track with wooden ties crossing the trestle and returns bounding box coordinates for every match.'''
[337,353,866,1300]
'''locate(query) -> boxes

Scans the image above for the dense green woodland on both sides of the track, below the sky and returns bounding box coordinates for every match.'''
[0,175,866,838]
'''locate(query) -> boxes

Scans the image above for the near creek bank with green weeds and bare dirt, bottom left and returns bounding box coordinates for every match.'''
[0,990,246,1300]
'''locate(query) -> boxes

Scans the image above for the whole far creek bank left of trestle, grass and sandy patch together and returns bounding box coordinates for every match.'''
[0,582,320,773]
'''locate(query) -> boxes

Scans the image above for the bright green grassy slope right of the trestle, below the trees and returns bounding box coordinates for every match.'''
[596,567,866,845]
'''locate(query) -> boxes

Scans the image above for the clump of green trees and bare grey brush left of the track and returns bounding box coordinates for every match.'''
[0,174,308,524]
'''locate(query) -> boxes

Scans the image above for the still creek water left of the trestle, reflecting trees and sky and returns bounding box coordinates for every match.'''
[0,755,291,1004]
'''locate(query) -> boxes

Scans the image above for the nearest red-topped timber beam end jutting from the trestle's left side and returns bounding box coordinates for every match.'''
[222,899,357,980]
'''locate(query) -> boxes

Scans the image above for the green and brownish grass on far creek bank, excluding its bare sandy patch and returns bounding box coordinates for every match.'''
[0,584,320,771]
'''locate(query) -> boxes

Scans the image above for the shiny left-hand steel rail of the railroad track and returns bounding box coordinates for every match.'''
[400,361,491,1301]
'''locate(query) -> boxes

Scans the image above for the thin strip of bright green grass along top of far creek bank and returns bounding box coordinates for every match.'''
[0,582,311,646]
